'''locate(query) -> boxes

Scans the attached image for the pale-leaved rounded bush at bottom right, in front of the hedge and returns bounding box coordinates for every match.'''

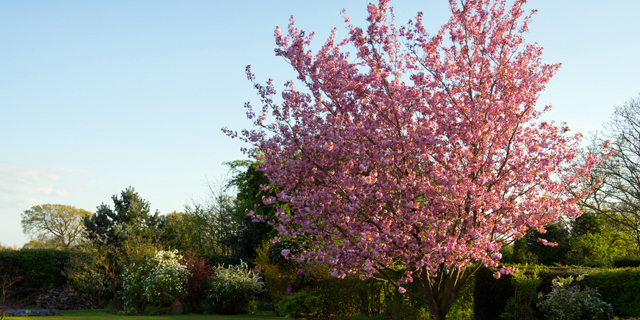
[538,276,613,320]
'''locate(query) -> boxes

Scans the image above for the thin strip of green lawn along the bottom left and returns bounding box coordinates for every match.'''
[5,309,278,320]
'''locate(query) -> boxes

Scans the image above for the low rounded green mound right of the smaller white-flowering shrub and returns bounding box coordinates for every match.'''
[278,290,325,318]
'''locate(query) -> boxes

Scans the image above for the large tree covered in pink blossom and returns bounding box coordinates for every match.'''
[223,0,597,319]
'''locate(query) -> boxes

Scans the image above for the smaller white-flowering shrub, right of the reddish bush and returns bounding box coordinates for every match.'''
[207,261,264,314]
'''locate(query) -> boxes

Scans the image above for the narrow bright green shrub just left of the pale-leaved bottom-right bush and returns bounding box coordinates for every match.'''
[500,268,542,320]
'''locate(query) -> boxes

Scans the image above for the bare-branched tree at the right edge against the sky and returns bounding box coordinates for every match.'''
[582,96,640,255]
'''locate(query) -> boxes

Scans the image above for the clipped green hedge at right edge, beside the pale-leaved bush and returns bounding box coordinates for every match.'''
[584,268,640,317]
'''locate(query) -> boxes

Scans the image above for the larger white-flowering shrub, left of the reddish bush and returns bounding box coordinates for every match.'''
[120,251,190,310]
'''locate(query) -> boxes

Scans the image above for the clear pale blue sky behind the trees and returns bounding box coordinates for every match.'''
[0,0,640,246]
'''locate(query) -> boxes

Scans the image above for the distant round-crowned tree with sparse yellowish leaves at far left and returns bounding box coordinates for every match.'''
[21,204,91,248]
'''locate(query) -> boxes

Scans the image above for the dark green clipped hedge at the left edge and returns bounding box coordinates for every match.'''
[0,249,75,289]
